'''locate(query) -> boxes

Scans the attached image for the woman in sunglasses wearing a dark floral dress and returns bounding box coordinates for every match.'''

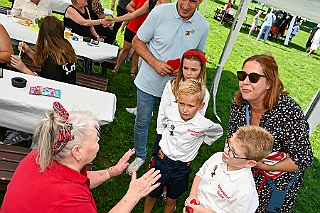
[228,54,313,212]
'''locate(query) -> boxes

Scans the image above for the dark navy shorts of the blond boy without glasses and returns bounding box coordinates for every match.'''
[149,152,191,199]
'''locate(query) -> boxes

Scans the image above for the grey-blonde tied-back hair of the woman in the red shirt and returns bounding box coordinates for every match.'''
[33,111,98,172]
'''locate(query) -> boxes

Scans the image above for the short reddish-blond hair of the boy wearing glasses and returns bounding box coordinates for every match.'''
[235,125,274,162]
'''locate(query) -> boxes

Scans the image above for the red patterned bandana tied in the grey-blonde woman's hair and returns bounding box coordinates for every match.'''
[52,101,74,154]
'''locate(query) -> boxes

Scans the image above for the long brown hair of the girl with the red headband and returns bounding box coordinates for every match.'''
[171,49,207,96]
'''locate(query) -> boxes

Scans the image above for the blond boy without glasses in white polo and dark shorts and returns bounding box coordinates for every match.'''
[144,79,223,213]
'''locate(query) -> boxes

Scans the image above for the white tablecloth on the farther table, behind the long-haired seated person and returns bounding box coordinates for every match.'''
[0,14,118,61]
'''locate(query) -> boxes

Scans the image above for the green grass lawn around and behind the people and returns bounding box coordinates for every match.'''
[0,0,320,213]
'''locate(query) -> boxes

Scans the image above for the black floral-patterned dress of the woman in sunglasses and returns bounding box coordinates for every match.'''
[228,94,313,212]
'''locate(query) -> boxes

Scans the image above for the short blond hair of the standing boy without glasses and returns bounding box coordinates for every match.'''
[176,79,206,102]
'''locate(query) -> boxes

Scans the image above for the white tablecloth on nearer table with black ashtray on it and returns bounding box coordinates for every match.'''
[0,70,116,133]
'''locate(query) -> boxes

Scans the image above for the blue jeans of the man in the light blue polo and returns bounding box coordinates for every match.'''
[134,88,158,160]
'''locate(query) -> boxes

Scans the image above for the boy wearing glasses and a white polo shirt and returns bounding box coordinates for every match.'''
[184,125,274,213]
